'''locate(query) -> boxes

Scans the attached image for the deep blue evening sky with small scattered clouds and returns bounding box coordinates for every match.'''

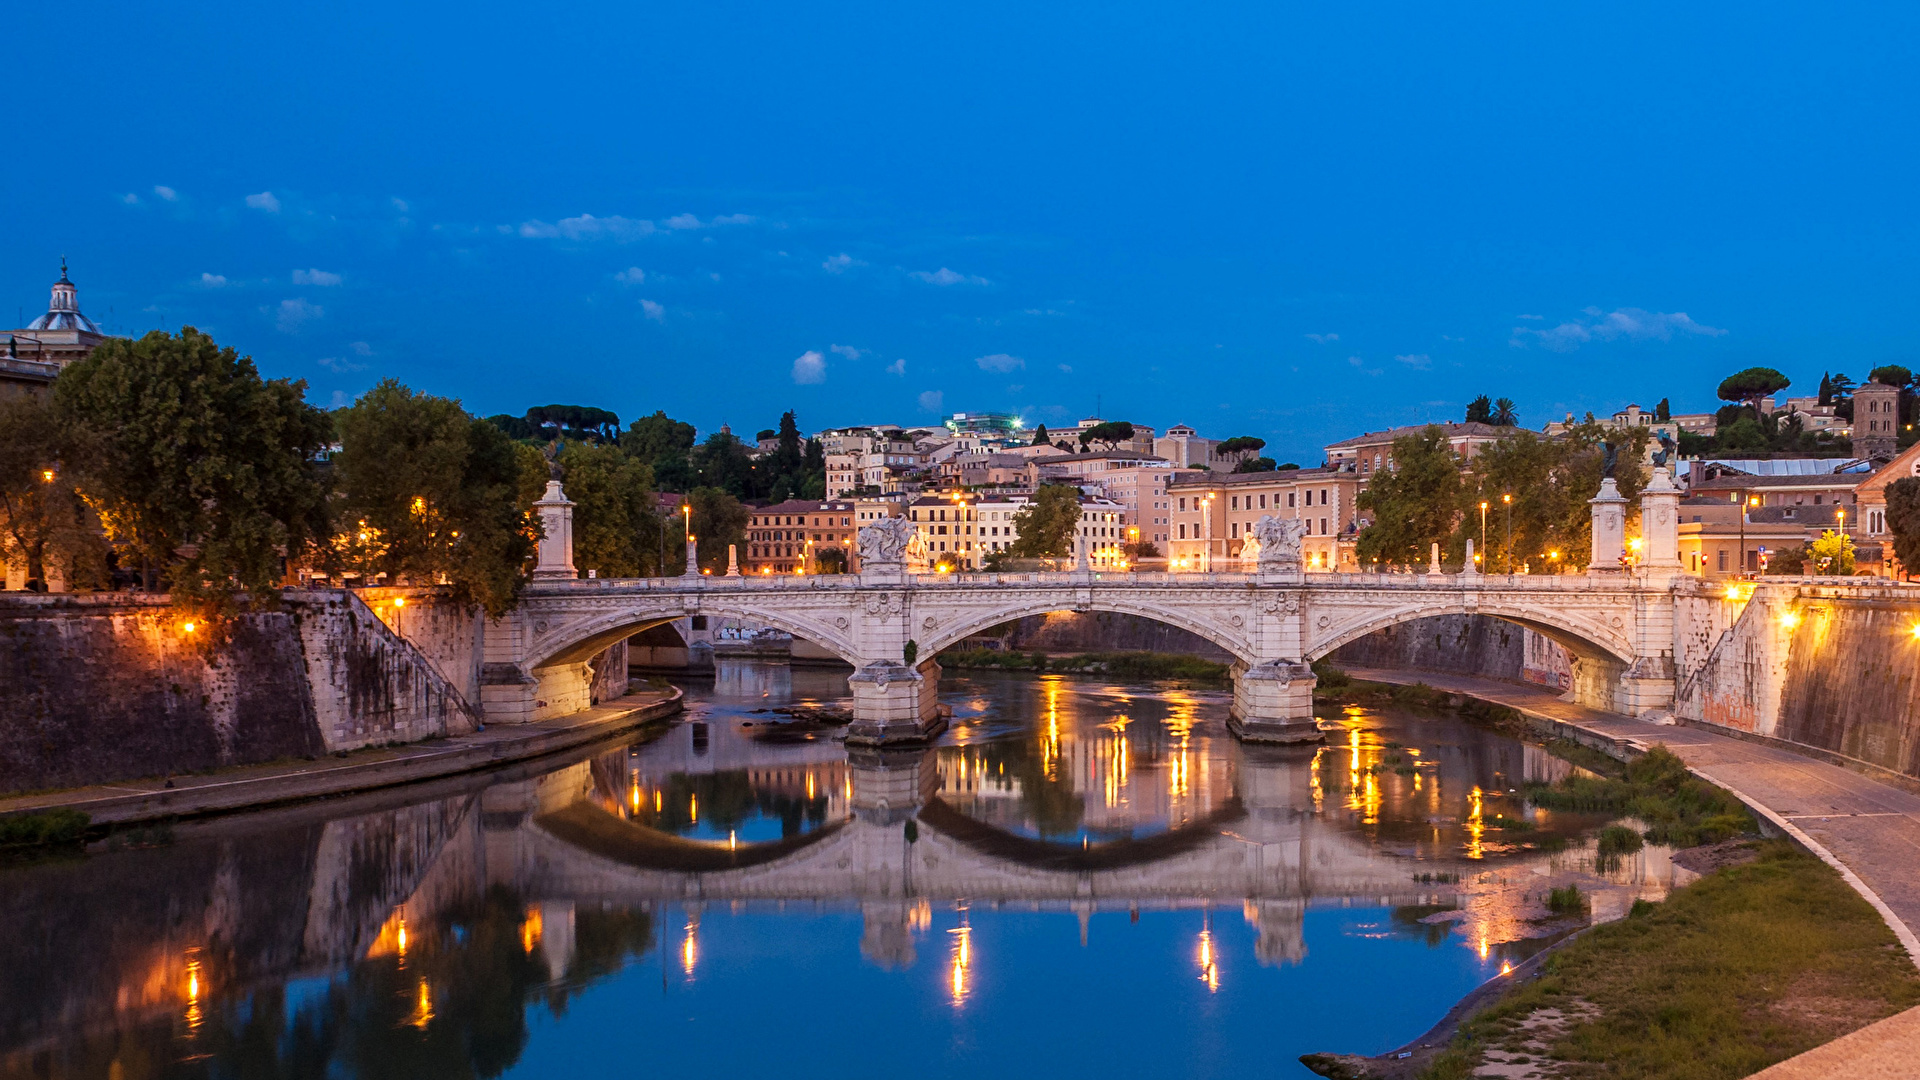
[0,2,1920,461]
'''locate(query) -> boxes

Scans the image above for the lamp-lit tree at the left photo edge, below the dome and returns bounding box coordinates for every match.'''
[0,396,108,588]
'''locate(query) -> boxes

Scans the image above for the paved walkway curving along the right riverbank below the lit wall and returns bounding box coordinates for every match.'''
[1346,667,1920,1080]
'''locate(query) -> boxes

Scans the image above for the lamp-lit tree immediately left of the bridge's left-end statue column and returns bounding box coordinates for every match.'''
[332,379,547,617]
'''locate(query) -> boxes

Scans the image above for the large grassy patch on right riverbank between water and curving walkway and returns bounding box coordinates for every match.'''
[1421,842,1920,1080]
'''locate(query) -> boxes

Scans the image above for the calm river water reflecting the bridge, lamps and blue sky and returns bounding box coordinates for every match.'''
[0,663,1684,1080]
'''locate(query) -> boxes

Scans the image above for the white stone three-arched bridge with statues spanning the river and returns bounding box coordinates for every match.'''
[482,469,1730,746]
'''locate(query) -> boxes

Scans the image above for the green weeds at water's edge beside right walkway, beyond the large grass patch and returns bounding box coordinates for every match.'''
[1526,746,1753,847]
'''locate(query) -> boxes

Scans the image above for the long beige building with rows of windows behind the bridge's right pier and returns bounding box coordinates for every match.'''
[1167,467,1369,571]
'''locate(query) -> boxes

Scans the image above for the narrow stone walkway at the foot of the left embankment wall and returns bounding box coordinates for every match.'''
[0,688,682,824]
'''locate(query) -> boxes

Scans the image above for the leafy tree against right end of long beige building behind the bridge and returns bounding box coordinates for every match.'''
[1356,425,1461,565]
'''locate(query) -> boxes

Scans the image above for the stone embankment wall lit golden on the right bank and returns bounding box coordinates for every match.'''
[1674,584,1920,776]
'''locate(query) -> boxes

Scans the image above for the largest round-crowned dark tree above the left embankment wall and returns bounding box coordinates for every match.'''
[54,327,330,615]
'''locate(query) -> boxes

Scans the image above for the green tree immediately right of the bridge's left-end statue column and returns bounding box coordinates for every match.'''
[559,442,666,577]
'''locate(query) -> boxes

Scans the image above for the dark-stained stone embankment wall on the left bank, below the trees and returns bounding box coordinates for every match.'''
[0,592,478,792]
